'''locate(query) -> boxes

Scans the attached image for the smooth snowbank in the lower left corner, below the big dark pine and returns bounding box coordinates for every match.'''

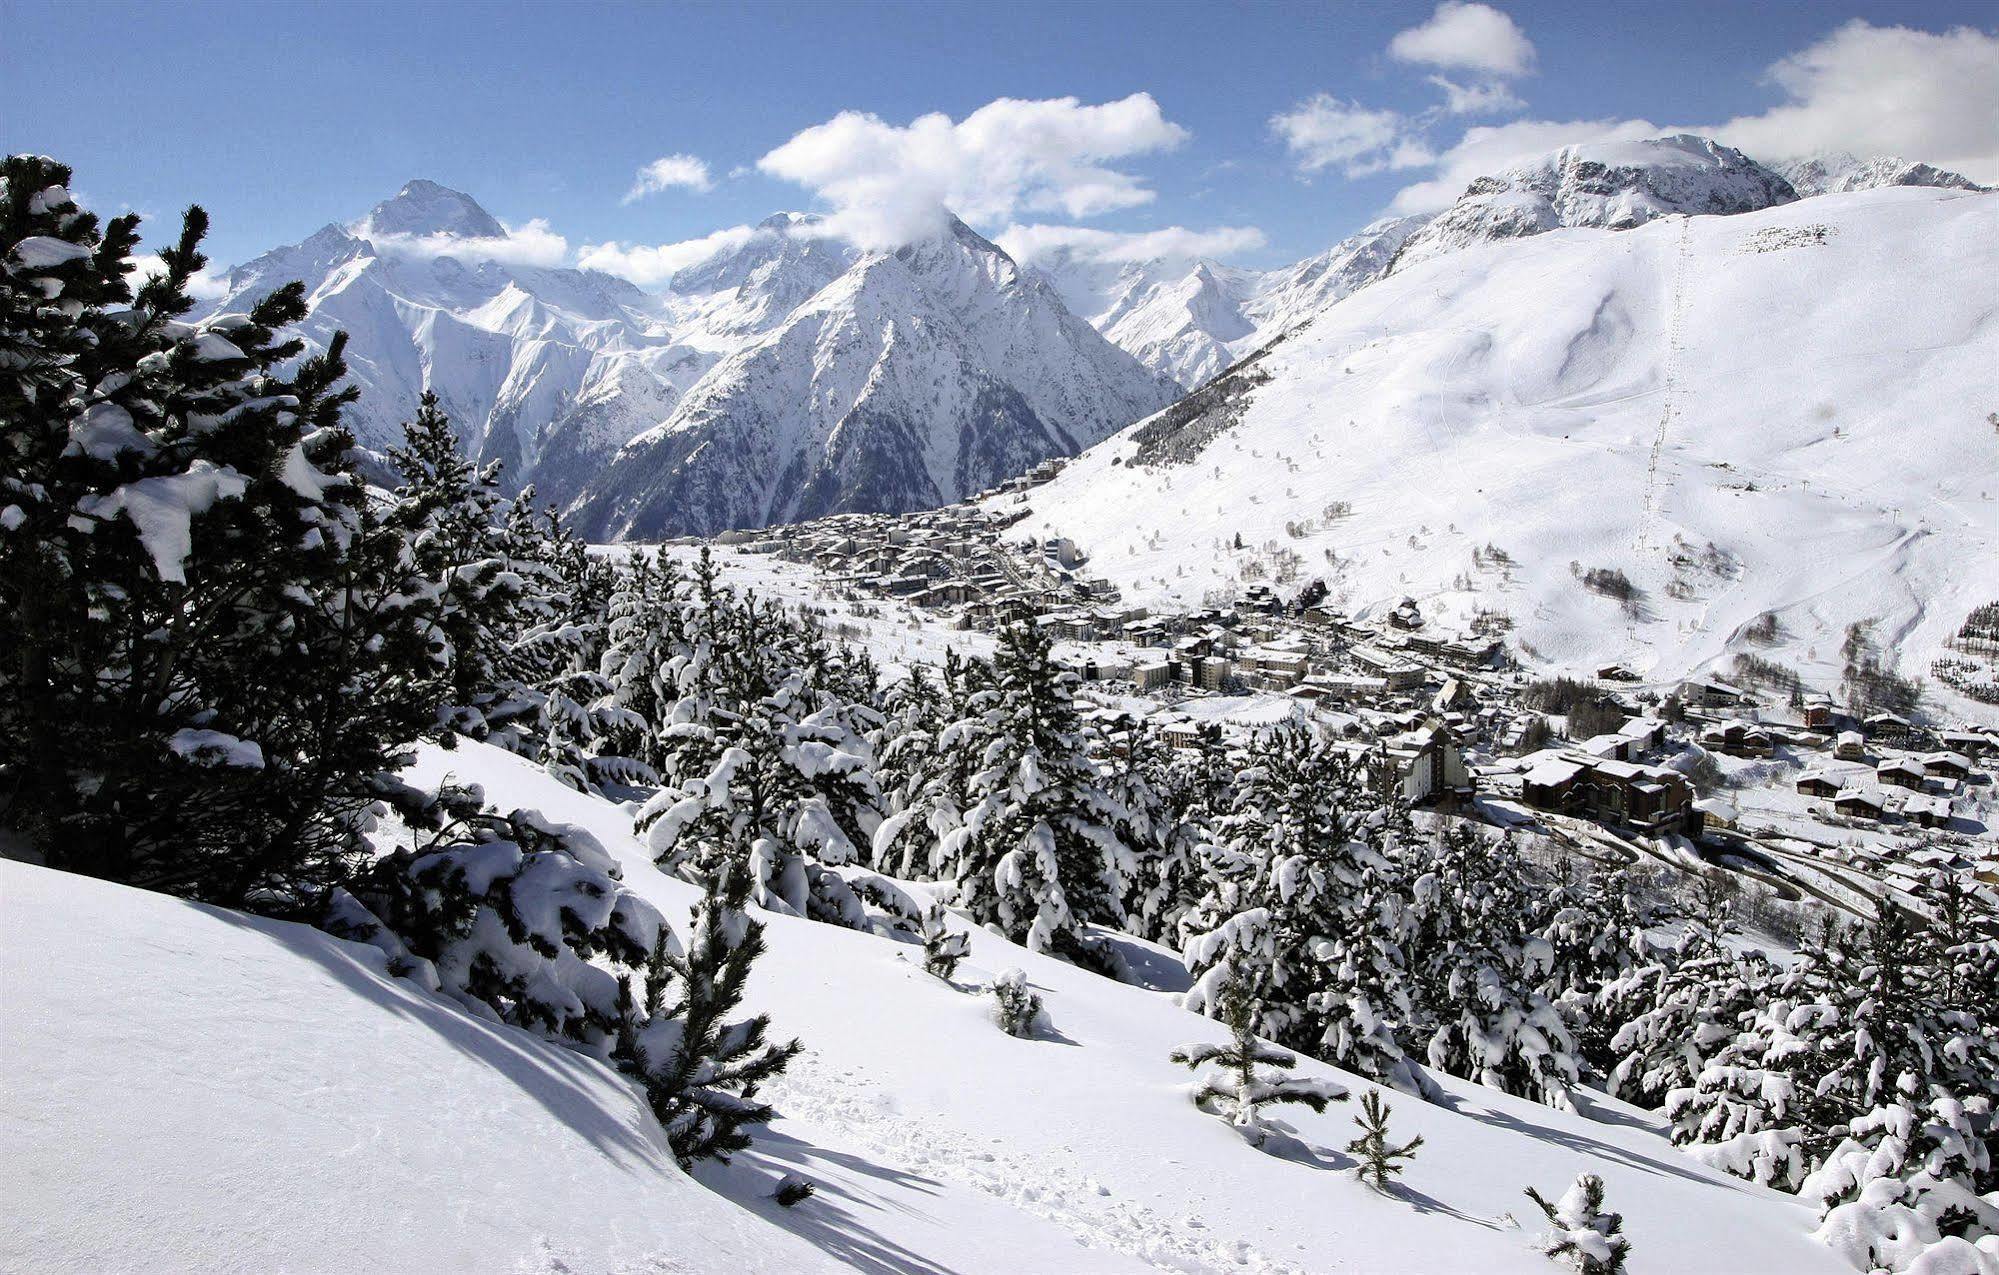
[0,861,838,1275]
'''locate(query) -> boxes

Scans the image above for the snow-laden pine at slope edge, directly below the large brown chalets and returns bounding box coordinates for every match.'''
[1409,823,1579,1109]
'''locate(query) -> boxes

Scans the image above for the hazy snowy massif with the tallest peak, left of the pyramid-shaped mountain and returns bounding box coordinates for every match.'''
[216,182,852,502]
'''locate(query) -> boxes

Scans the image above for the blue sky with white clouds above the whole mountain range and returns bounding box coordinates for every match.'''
[0,0,1999,276]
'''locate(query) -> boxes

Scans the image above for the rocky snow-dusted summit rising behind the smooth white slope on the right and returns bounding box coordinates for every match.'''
[1391,134,1797,270]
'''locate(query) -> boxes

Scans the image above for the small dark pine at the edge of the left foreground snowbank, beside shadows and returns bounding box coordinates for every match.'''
[622,863,800,1165]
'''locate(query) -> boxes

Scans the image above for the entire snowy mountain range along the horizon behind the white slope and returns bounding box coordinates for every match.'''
[198,136,1979,540]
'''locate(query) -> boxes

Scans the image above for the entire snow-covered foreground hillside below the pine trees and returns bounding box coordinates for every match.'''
[0,743,1845,1275]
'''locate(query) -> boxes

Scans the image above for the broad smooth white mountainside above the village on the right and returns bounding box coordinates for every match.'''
[1021,188,1999,711]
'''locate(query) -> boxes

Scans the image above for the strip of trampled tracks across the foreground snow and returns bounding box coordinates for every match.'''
[768,1057,1307,1275]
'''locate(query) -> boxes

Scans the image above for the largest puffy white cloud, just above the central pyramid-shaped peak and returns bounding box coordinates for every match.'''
[758,94,1189,248]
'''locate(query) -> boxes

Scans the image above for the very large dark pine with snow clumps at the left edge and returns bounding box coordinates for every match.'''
[0,156,434,911]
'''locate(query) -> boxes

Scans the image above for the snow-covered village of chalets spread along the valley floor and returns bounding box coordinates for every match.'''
[666,460,1999,929]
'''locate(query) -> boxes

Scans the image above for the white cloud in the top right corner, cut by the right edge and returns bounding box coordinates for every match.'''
[1709,18,1999,182]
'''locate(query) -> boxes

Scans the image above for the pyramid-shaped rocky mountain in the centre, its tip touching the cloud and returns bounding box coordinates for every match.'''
[574,222,1177,540]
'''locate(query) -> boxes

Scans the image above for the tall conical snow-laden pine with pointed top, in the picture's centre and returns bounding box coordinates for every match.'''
[940,624,1131,973]
